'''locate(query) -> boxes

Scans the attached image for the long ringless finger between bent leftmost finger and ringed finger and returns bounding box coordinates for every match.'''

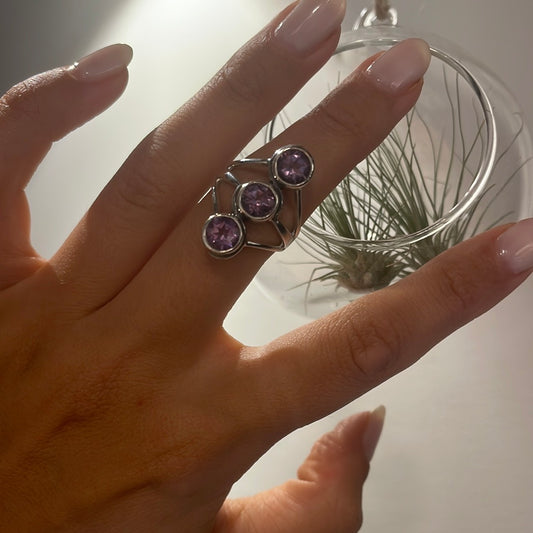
[47,0,345,308]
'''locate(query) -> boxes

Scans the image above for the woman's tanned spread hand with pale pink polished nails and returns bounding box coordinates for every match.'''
[0,0,533,533]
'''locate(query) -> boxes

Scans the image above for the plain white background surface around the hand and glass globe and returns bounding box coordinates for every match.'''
[5,0,533,533]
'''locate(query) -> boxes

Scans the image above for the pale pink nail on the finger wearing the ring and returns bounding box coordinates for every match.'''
[366,39,431,93]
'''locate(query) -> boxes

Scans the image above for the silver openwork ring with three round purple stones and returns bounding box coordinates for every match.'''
[202,145,315,258]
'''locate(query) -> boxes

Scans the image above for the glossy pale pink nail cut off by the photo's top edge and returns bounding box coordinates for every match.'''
[275,0,346,53]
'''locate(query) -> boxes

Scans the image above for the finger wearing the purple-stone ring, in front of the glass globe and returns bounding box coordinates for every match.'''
[114,40,430,331]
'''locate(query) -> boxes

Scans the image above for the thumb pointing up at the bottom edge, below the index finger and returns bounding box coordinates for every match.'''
[215,408,385,533]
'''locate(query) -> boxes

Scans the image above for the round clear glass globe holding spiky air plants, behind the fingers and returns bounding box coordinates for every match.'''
[256,17,533,317]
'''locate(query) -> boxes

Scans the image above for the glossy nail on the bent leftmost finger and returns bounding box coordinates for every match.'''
[67,44,133,82]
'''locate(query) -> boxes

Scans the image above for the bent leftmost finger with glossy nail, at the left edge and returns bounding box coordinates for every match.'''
[0,45,131,288]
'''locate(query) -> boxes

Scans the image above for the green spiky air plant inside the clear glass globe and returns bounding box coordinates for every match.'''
[298,71,525,291]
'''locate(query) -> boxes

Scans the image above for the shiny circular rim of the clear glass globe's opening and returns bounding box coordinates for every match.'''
[306,31,497,251]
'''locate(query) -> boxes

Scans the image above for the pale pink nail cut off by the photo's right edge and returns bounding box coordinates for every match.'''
[496,218,533,274]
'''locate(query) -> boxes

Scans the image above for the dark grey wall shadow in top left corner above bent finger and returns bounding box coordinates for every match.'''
[0,0,128,94]
